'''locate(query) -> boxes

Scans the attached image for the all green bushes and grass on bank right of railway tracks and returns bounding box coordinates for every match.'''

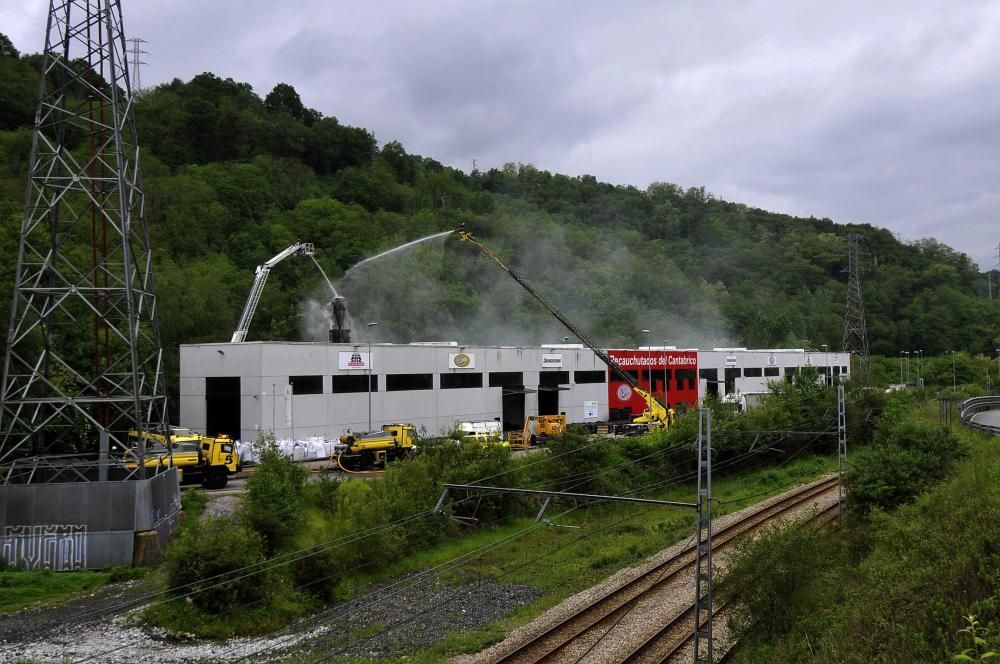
[722,411,1000,662]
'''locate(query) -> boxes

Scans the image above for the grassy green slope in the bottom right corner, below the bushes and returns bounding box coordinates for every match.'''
[732,402,1000,664]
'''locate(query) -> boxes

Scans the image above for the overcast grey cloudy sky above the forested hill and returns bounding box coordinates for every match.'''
[0,0,1000,269]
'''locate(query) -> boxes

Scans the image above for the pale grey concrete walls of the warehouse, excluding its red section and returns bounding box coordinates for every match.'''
[180,342,836,440]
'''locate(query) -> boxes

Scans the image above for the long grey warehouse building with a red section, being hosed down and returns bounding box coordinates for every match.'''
[180,342,850,441]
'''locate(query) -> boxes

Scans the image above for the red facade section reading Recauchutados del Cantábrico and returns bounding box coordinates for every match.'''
[608,350,698,415]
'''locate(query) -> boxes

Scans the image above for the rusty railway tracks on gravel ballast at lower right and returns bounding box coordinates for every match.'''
[491,477,837,664]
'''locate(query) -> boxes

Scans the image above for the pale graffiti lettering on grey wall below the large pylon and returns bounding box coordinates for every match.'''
[0,525,87,572]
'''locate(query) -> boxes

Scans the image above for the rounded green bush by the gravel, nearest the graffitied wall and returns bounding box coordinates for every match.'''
[164,518,267,614]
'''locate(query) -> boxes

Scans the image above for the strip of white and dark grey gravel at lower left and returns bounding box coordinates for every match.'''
[0,577,540,663]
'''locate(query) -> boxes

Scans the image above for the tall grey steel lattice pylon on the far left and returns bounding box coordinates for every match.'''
[0,0,167,462]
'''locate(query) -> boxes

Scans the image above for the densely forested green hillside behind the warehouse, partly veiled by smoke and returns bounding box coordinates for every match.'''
[0,36,1000,394]
